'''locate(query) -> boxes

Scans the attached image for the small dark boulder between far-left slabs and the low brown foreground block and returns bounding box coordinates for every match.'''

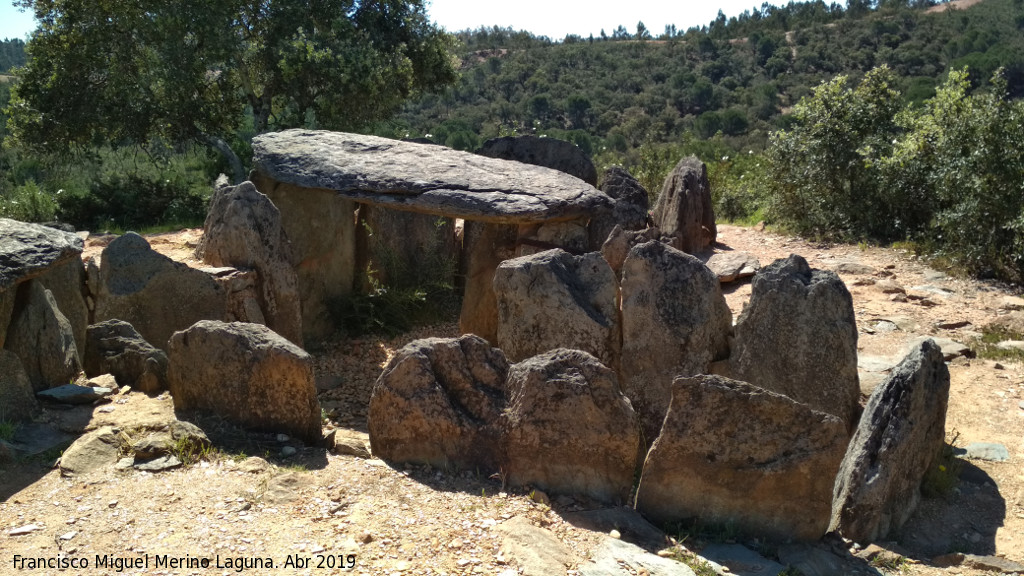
[85,320,167,394]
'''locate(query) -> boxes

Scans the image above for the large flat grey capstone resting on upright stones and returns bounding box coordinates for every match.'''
[253,129,611,223]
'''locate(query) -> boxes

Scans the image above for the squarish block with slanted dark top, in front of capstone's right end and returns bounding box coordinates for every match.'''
[494,249,618,366]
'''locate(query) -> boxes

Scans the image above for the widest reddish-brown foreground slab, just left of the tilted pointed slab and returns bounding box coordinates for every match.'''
[636,376,847,540]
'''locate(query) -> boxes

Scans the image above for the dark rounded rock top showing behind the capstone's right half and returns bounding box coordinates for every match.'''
[476,135,597,186]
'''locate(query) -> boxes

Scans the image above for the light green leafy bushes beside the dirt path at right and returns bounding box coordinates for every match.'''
[766,68,1024,280]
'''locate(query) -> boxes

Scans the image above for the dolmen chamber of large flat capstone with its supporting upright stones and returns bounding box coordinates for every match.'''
[250,130,614,341]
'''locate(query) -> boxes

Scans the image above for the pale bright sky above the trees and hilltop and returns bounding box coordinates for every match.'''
[0,0,761,40]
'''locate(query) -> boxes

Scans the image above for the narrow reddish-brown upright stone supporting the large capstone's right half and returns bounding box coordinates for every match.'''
[459,221,519,343]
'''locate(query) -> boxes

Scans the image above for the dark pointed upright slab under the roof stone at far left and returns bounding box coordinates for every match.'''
[5,280,82,392]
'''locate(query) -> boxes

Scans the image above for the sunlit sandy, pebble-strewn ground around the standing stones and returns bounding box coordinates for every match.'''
[0,225,1024,575]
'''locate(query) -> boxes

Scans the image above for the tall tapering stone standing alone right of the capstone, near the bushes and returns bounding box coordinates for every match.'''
[651,156,718,254]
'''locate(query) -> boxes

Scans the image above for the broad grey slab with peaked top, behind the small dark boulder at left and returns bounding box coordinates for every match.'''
[95,232,227,348]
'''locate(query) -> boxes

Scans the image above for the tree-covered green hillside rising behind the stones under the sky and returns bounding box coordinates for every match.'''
[381,0,1024,153]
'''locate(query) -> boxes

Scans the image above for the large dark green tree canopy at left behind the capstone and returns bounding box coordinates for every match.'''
[8,0,457,179]
